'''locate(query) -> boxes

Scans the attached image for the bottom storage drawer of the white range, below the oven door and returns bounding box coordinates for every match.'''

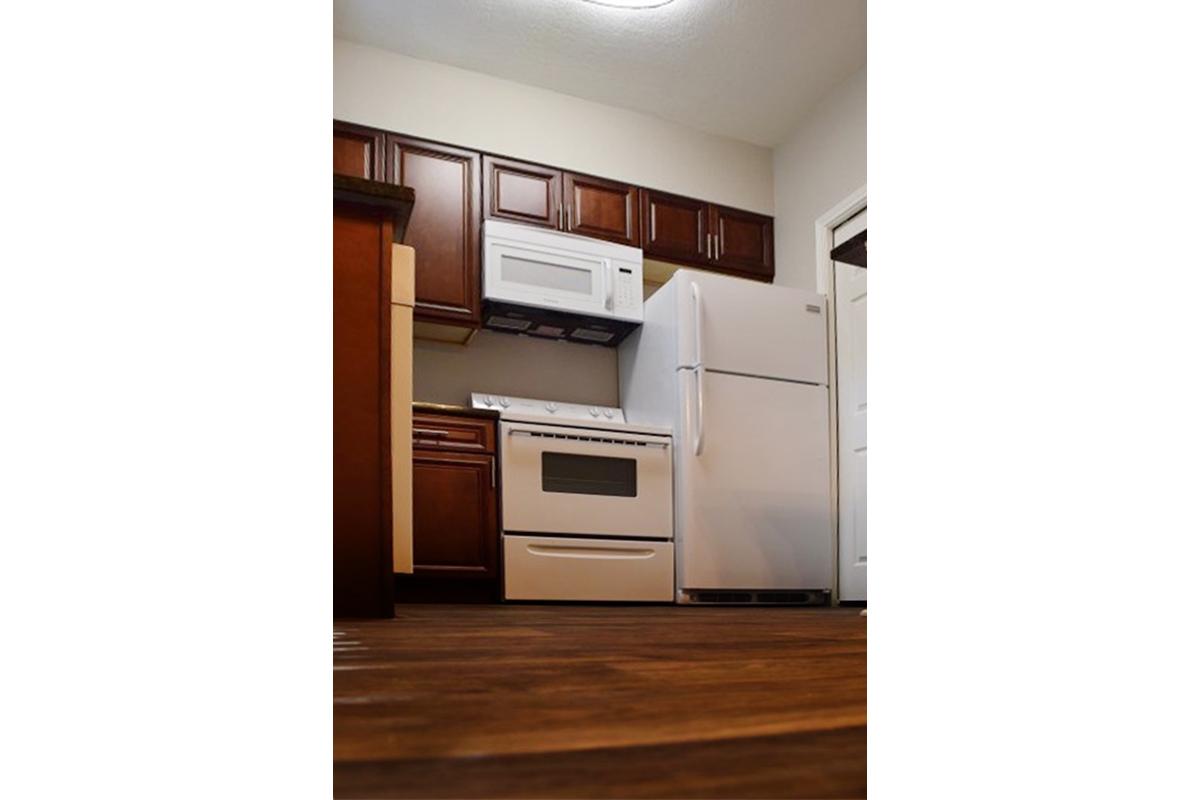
[504,535,674,602]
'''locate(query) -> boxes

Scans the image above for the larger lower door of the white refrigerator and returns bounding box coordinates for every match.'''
[676,369,834,589]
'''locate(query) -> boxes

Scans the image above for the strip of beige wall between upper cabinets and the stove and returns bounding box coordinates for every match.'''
[413,331,619,405]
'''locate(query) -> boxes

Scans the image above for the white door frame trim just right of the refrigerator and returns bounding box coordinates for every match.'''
[814,184,866,606]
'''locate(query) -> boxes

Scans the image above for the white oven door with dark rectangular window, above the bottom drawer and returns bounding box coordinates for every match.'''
[500,422,673,539]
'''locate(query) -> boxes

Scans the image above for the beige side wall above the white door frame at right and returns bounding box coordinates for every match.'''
[775,66,866,291]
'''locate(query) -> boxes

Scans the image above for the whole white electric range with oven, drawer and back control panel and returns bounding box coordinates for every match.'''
[472,392,674,602]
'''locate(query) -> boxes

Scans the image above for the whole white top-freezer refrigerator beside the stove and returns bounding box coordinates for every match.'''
[618,270,835,602]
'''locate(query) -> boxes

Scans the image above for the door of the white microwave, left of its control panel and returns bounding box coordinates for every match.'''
[484,236,613,317]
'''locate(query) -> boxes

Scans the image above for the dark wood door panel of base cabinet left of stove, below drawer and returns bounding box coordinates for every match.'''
[413,450,499,579]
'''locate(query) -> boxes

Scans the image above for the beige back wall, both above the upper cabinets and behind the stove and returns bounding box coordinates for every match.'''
[334,40,774,405]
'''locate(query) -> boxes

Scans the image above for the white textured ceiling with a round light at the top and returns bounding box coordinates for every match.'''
[334,0,866,146]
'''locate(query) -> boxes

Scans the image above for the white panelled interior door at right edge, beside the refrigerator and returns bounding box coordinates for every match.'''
[834,264,866,601]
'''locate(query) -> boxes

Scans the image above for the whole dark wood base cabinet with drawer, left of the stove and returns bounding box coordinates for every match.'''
[396,414,500,602]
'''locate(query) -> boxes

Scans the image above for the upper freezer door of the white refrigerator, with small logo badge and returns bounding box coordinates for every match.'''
[672,270,829,384]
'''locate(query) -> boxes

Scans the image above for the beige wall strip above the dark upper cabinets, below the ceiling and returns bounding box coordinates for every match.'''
[334,40,775,215]
